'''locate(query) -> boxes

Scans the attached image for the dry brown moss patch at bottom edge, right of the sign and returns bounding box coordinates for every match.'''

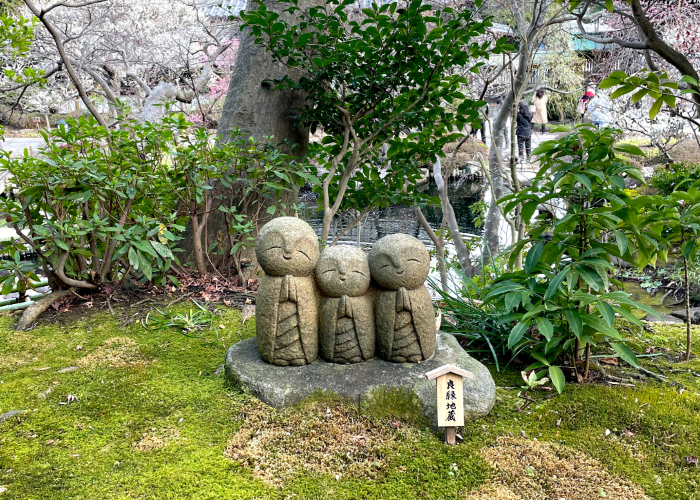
[467,436,647,500]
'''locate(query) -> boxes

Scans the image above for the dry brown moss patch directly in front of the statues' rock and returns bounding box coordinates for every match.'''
[224,400,417,487]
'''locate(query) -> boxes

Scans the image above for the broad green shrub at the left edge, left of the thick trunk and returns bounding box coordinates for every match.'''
[0,113,184,289]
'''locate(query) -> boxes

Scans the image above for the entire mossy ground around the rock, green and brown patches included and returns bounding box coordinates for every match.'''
[0,300,700,500]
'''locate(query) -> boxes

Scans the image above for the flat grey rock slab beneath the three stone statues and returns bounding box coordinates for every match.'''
[225,332,496,423]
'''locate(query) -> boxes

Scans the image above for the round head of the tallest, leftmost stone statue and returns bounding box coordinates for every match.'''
[255,217,319,276]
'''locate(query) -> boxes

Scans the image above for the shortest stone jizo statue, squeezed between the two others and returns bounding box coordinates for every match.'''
[316,245,375,364]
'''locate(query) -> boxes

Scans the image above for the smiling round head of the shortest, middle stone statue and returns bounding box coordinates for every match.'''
[316,245,371,297]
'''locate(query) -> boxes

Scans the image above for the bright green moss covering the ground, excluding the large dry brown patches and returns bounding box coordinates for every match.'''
[0,304,700,500]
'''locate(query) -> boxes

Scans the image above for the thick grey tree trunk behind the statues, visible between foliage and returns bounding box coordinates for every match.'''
[181,0,317,274]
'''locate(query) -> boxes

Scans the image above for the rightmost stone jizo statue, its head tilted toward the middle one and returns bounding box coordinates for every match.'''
[369,234,436,363]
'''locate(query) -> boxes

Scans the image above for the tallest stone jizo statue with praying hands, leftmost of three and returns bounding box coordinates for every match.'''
[255,217,319,366]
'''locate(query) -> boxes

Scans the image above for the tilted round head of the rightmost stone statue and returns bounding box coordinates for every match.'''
[369,233,430,290]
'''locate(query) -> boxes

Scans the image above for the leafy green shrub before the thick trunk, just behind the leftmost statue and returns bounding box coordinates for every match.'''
[159,115,319,276]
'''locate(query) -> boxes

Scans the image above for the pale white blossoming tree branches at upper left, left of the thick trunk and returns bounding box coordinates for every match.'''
[0,0,236,124]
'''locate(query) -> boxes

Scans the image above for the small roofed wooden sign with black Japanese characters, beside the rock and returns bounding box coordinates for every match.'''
[425,365,474,444]
